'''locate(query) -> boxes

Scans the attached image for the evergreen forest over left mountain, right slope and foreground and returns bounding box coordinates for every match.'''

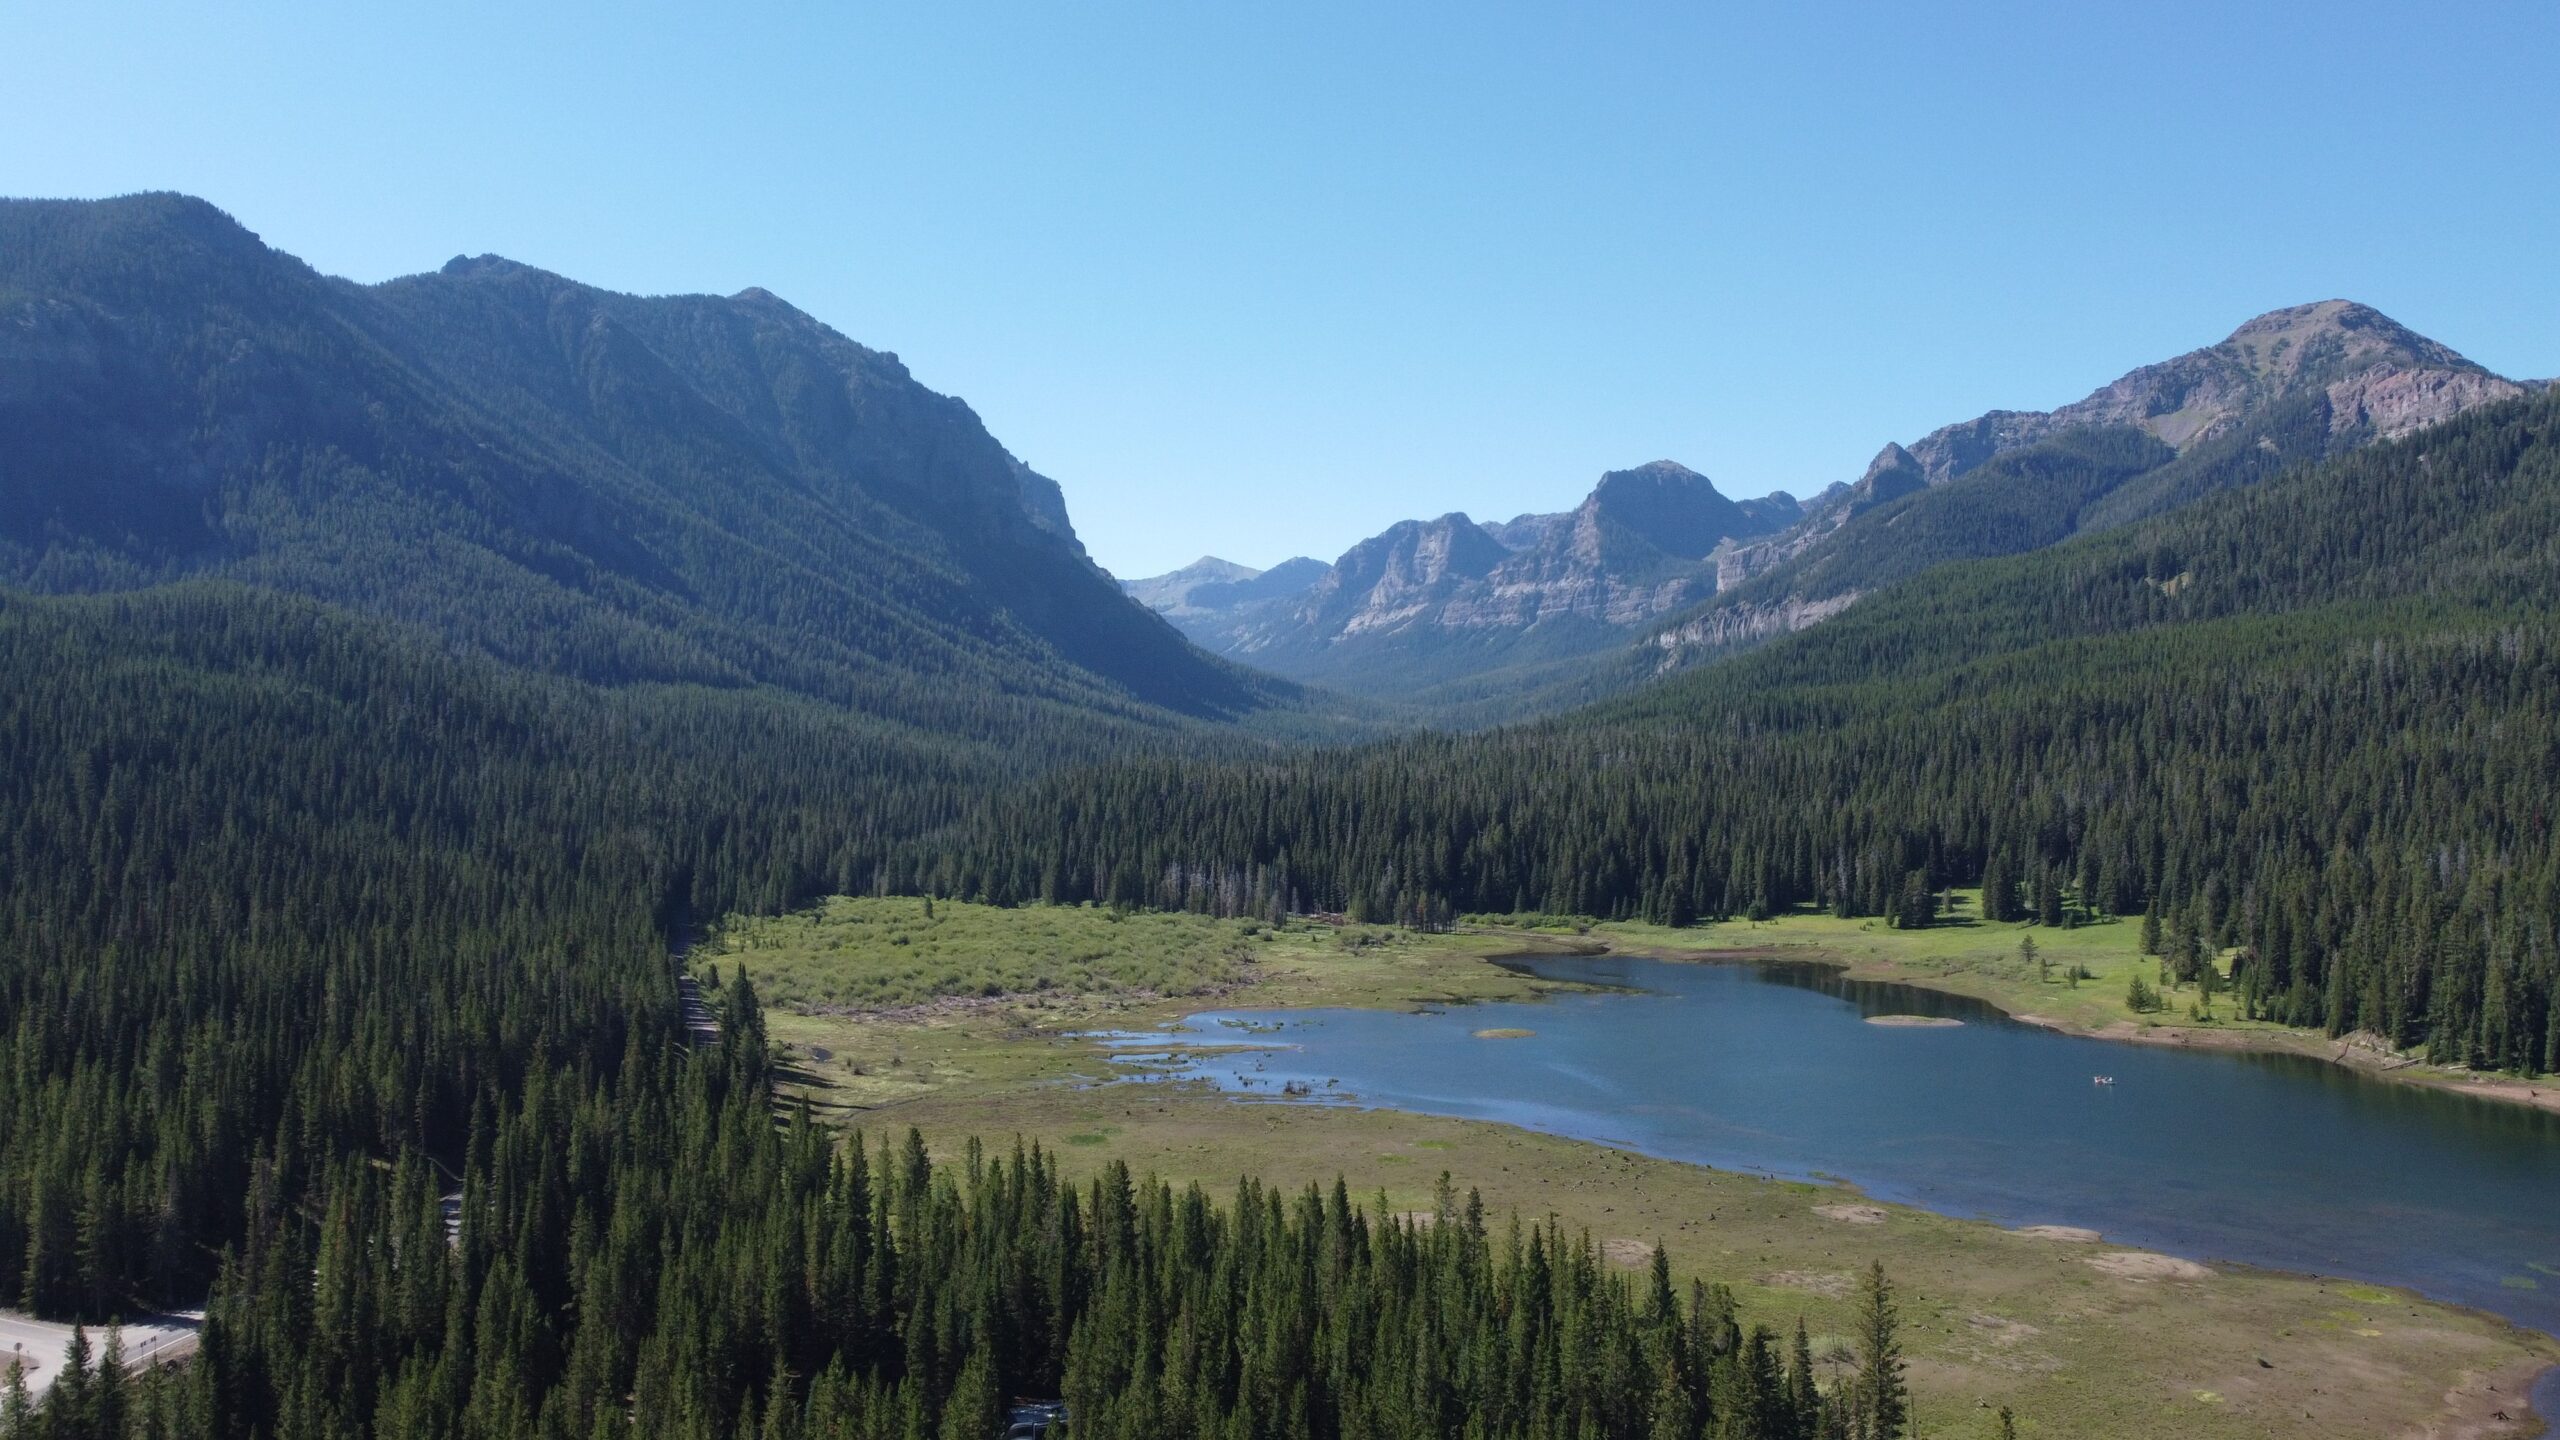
[0,197,2560,1440]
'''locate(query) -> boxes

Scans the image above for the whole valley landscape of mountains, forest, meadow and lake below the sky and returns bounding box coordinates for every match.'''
[0,195,2560,1440]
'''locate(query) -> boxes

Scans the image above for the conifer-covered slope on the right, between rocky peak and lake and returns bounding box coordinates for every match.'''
[952,397,2560,1068]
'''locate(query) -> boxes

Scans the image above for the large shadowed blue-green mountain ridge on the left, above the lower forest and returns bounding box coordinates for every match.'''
[0,195,1293,735]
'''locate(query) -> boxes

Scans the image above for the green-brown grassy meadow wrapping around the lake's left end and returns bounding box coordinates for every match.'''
[696,899,2560,1437]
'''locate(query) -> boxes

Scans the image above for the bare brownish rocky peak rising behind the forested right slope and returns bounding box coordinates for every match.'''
[1654,300,2527,666]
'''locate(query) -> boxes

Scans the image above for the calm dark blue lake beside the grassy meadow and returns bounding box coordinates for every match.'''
[1121,956,2560,1332]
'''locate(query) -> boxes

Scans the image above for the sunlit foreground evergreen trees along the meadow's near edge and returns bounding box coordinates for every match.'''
[0,953,1907,1440]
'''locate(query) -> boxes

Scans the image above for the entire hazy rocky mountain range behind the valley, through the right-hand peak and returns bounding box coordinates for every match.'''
[1126,300,2529,712]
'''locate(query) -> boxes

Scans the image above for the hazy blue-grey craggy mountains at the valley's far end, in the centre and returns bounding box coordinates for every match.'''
[1129,461,1802,700]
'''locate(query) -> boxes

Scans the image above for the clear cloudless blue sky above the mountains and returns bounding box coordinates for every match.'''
[0,0,2560,577]
